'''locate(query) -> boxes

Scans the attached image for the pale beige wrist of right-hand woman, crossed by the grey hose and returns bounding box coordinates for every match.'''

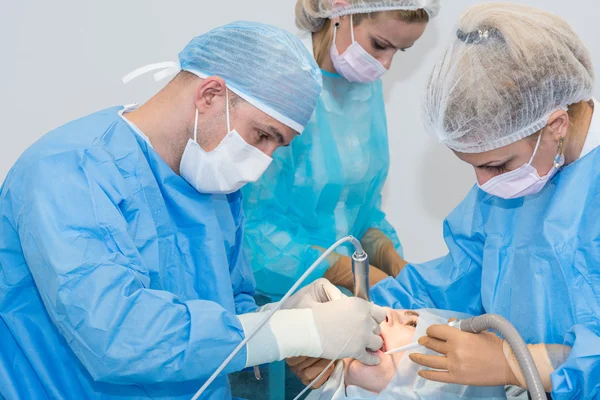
[504,341,571,393]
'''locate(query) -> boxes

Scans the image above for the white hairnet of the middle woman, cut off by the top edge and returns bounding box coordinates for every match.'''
[296,0,440,32]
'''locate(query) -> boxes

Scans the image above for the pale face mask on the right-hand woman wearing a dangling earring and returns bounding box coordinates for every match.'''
[479,133,565,200]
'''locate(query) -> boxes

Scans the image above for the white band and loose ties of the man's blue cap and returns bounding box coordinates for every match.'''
[121,61,304,134]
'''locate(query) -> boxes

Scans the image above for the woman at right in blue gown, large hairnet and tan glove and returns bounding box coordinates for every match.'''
[372,3,600,399]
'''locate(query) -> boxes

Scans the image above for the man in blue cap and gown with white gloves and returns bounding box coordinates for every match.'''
[0,22,385,399]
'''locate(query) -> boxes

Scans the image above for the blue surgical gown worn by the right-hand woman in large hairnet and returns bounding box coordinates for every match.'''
[371,148,600,400]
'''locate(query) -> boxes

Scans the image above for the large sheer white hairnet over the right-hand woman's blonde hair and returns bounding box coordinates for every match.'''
[424,3,594,153]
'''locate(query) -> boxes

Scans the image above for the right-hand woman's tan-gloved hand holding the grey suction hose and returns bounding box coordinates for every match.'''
[409,325,519,386]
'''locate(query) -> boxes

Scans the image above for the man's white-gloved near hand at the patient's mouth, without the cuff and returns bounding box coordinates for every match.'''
[312,297,386,365]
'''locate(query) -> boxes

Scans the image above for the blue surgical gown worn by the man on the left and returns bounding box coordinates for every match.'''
[0,107,256,400]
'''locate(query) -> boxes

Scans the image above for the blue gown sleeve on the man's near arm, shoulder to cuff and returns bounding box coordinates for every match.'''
[14,154,246,384]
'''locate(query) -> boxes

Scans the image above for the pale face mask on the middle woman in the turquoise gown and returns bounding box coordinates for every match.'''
[330,14,387,83]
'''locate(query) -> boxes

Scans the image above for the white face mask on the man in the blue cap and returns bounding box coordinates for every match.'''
[179,91,273,194]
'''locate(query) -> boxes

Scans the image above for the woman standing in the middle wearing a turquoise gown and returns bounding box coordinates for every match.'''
[243,0,440,297]
